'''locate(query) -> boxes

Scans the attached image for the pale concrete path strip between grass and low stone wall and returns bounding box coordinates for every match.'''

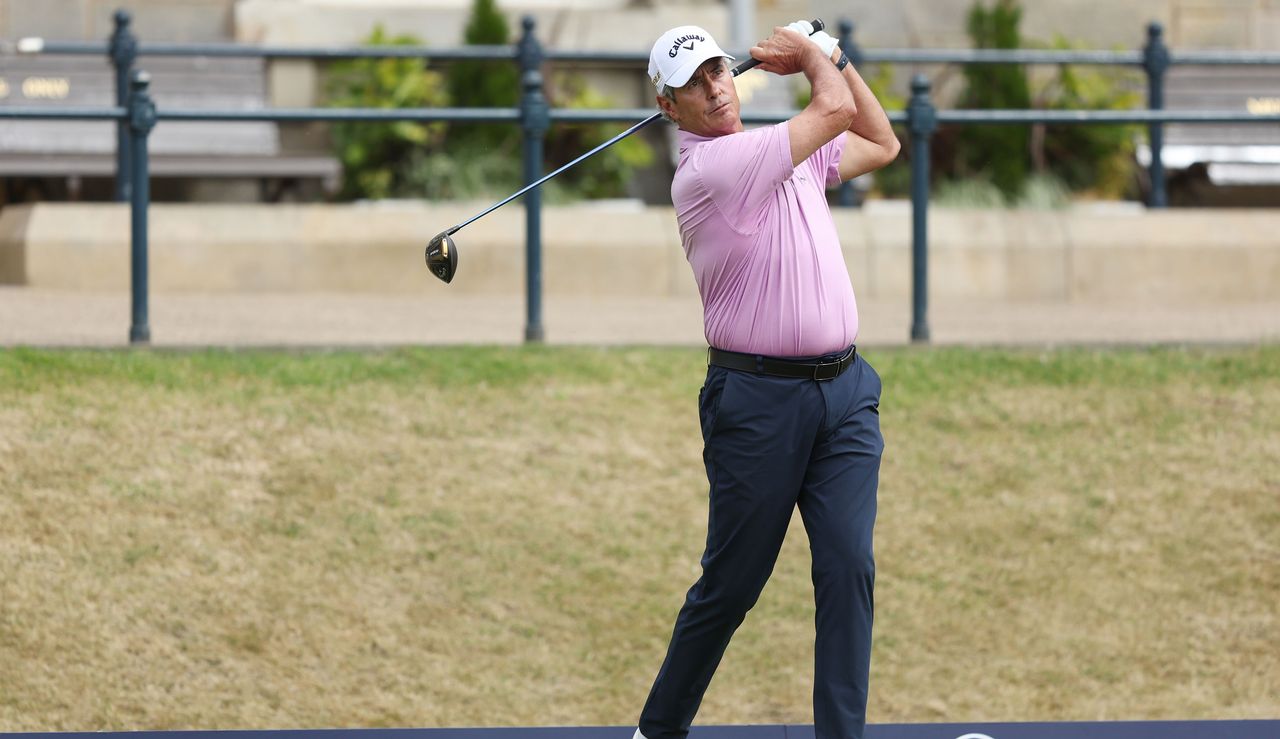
[0,287,1280,347]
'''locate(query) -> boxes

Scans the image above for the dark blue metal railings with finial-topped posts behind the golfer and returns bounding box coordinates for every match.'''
[0,10,1280,343]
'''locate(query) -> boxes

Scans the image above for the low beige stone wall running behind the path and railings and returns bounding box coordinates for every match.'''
[0,202,1280,304]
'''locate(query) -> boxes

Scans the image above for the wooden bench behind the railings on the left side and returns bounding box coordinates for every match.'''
[0,55,342,200]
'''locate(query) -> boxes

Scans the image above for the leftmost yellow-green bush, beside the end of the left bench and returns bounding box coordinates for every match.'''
[325,26,448,199]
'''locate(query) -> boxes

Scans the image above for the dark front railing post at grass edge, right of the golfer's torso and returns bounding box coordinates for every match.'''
[906,74,938,343]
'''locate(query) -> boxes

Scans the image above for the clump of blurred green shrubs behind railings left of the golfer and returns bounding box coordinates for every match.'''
[326,0,653,202]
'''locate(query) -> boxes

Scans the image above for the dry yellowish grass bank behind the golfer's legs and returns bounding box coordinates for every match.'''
[0,347,1280,731]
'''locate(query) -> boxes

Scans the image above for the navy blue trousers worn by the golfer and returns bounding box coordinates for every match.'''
[640,356,884,739]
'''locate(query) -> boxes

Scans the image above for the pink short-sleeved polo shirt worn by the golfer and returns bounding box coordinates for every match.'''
[671,123,858,357]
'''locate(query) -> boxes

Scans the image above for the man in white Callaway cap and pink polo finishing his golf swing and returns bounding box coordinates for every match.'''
[635,22,899,739]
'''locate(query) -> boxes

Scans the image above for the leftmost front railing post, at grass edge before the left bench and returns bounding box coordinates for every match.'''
[128,70,156,345]
